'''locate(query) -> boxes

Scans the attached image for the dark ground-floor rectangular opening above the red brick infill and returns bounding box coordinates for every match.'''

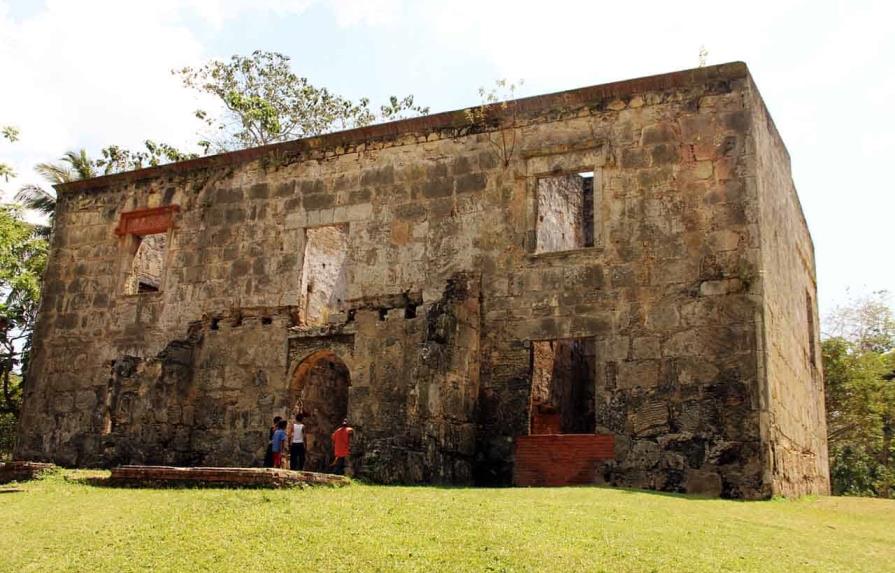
[529,338,596,434]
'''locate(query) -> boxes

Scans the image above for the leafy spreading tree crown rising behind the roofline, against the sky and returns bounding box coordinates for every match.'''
[172,50,429,151]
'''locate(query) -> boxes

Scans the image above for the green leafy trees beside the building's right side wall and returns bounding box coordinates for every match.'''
[821,292,895,497]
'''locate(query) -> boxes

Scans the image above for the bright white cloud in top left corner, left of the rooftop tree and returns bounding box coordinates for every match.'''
[0,0,211,199]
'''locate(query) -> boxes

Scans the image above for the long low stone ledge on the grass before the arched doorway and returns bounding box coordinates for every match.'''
[107,466,351,487]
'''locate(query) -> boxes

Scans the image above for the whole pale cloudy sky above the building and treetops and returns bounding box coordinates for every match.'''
[0,0,895,311]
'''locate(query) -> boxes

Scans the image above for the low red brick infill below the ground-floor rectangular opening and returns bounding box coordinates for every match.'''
[513,434,615,486]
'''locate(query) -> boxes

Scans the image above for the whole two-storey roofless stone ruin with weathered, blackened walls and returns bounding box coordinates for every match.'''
[16,63,829,498]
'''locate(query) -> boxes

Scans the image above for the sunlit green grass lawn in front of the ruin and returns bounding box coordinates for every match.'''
[0,472,895,573]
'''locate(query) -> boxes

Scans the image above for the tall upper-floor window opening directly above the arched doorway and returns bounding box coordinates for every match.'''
[299,225,348,326]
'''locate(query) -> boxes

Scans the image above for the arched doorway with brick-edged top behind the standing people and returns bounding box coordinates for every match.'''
[289,350,351,472]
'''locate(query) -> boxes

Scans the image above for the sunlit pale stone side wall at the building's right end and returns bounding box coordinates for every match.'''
[747,80,830,496]
